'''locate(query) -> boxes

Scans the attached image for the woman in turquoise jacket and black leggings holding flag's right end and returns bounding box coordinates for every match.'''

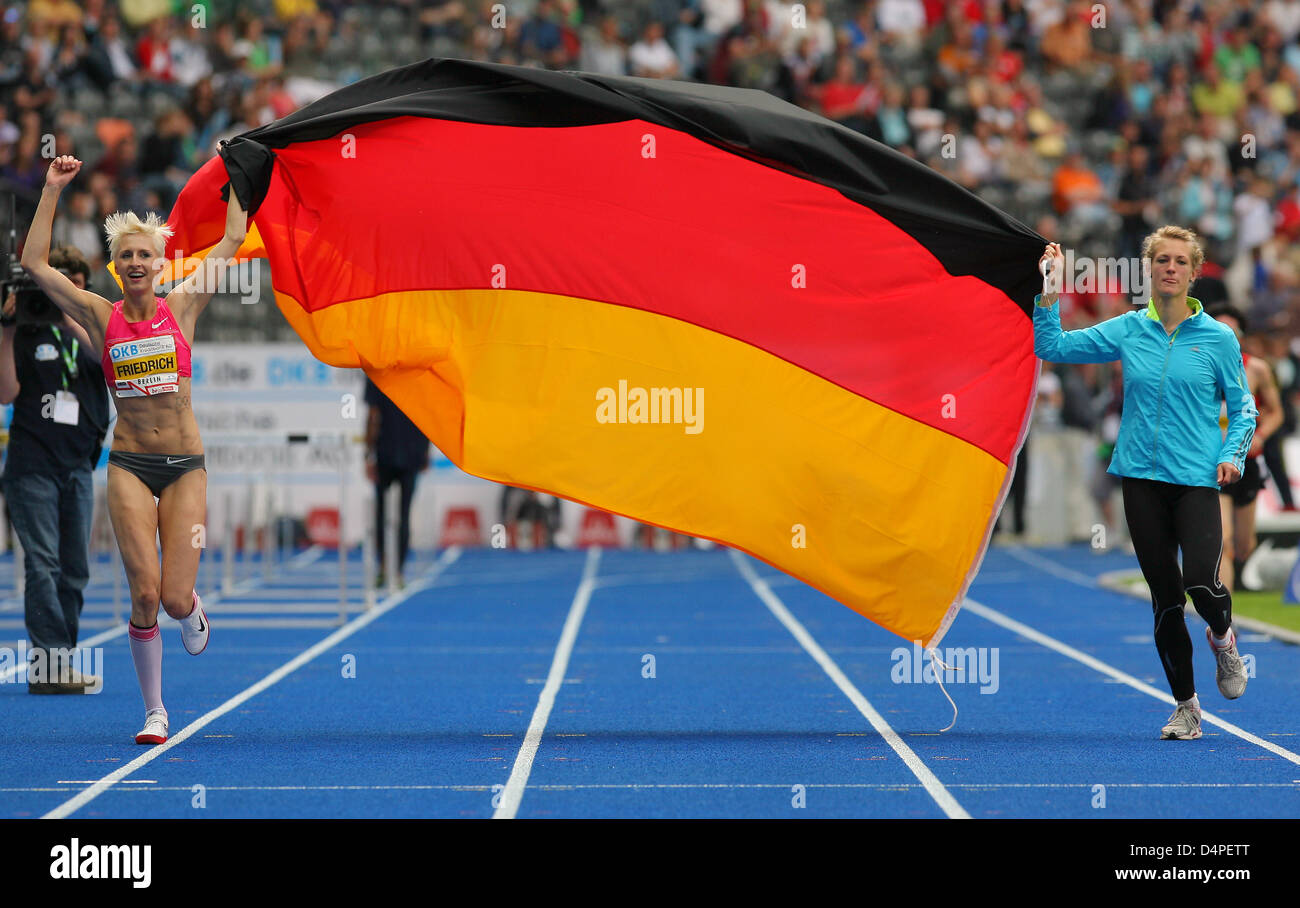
[1034,226,1256,739]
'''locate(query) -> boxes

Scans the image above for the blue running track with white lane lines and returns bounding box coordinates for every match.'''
[0,546,1300,818]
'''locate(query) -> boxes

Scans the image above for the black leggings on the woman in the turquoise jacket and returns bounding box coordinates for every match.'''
[1123,476,1232,700]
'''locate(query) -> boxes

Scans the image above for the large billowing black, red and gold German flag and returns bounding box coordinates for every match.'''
[170,60,1044,645]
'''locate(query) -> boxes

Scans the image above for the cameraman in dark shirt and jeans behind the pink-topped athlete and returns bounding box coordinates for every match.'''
[0,247,108,693]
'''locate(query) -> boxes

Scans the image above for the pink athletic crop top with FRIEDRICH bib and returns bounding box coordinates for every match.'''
[100,297,190,397]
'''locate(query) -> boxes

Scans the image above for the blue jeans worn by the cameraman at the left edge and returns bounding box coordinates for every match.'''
[4,470,95,649]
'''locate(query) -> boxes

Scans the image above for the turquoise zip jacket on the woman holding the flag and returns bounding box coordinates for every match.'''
[1034,294,1257,489]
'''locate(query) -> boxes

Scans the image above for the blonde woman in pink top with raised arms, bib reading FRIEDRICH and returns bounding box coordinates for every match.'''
[22,155,248,744]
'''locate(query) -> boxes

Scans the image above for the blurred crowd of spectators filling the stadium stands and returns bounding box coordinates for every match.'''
[0,0,1300,537]
